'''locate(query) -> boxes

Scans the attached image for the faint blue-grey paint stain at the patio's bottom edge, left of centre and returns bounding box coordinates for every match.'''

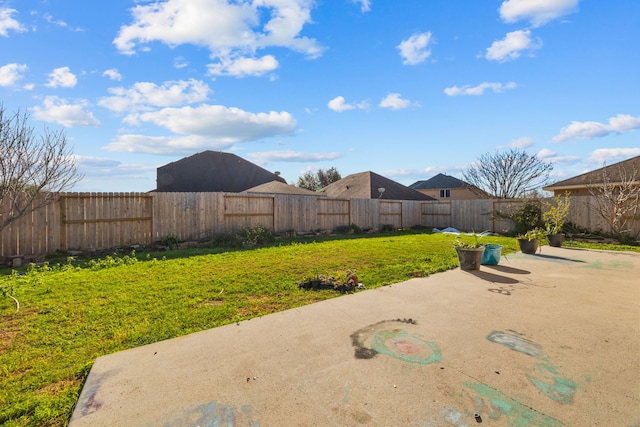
[159,402,260,427]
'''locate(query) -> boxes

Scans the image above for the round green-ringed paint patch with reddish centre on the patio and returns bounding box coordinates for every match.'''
[371,329,442,364]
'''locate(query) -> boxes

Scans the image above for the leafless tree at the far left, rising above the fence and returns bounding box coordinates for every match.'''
[0,105,82,231]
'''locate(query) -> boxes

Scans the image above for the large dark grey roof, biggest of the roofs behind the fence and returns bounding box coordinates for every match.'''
[156,151,286,193]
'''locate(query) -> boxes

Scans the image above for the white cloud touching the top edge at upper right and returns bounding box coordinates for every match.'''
[499,0,580,27]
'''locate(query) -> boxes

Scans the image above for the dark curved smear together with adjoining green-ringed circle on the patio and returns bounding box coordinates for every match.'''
[351,319,442,364]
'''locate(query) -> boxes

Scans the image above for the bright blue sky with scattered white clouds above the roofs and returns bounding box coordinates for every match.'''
[0,0,640,191]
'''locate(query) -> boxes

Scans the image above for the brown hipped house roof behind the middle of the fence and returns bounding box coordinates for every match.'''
[322,172,433,200]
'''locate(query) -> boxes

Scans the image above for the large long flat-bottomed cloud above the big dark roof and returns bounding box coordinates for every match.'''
[125,105,297,144]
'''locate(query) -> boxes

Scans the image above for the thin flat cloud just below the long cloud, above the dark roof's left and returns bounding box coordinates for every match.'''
[103,134,233,154]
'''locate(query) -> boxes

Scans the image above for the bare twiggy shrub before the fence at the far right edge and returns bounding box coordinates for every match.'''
[587,164,640,239]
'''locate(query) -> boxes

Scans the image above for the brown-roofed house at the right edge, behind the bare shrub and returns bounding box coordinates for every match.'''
[543,156,640,196]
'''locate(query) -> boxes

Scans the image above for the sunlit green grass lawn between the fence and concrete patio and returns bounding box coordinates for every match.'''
[0,232,638,426]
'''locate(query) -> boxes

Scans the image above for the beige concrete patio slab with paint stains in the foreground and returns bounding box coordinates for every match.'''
[70,246,640,427]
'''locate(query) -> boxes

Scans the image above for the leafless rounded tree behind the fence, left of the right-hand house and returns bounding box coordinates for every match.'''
[462,148,553,199]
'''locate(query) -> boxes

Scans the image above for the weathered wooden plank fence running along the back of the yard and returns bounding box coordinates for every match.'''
[0,193,640,257]
